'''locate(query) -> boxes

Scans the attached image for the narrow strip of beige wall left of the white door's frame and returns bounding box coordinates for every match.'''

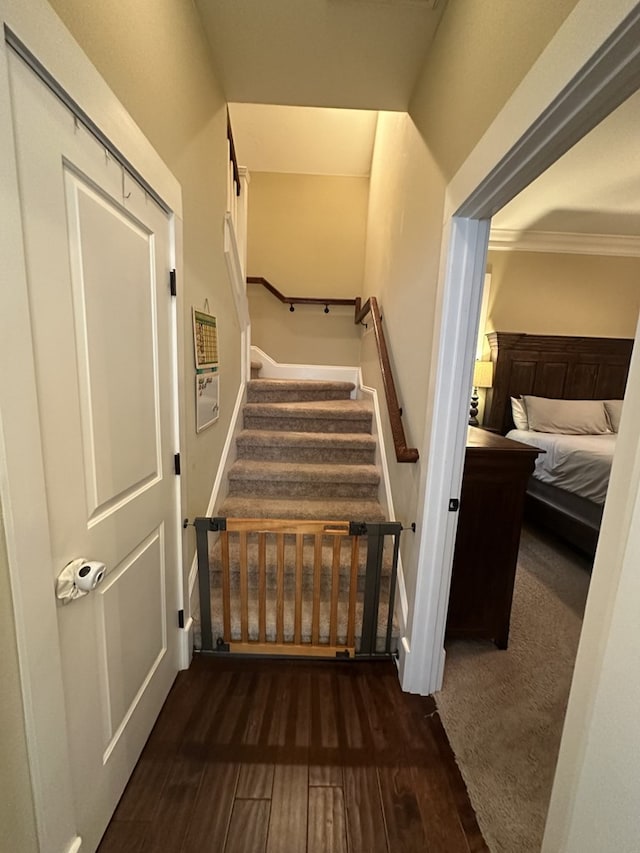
[0,511,38,853]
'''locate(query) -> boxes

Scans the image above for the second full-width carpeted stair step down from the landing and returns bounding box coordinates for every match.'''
[244,400,372,433]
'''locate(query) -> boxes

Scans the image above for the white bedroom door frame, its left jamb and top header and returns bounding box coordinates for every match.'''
[401,0,640,693]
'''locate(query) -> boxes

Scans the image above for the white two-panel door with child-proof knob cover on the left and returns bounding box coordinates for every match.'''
[10,50,179,852]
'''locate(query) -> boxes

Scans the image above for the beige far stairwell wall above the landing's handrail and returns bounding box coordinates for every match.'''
[247,172,369,298]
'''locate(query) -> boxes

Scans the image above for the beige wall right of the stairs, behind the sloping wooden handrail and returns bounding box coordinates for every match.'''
[362,113,445,620]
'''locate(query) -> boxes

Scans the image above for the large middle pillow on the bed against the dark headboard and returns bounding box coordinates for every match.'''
[523,396,611,435]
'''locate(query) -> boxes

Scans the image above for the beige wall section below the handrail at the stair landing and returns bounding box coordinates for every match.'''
[248,284,360,365]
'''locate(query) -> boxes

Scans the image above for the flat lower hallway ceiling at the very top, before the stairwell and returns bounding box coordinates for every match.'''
[196,0,446,110]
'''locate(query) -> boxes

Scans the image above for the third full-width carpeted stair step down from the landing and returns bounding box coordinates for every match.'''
[236,429,376,465]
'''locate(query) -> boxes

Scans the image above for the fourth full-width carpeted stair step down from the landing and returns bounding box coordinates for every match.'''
[229,459,380,500]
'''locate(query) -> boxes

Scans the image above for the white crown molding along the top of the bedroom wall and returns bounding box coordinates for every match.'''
[489,228,640,258]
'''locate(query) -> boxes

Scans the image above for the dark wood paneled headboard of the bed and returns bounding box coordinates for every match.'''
[484,332,633,435]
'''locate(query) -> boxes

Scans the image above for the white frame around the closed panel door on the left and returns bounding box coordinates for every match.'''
[0,0,186,853]
